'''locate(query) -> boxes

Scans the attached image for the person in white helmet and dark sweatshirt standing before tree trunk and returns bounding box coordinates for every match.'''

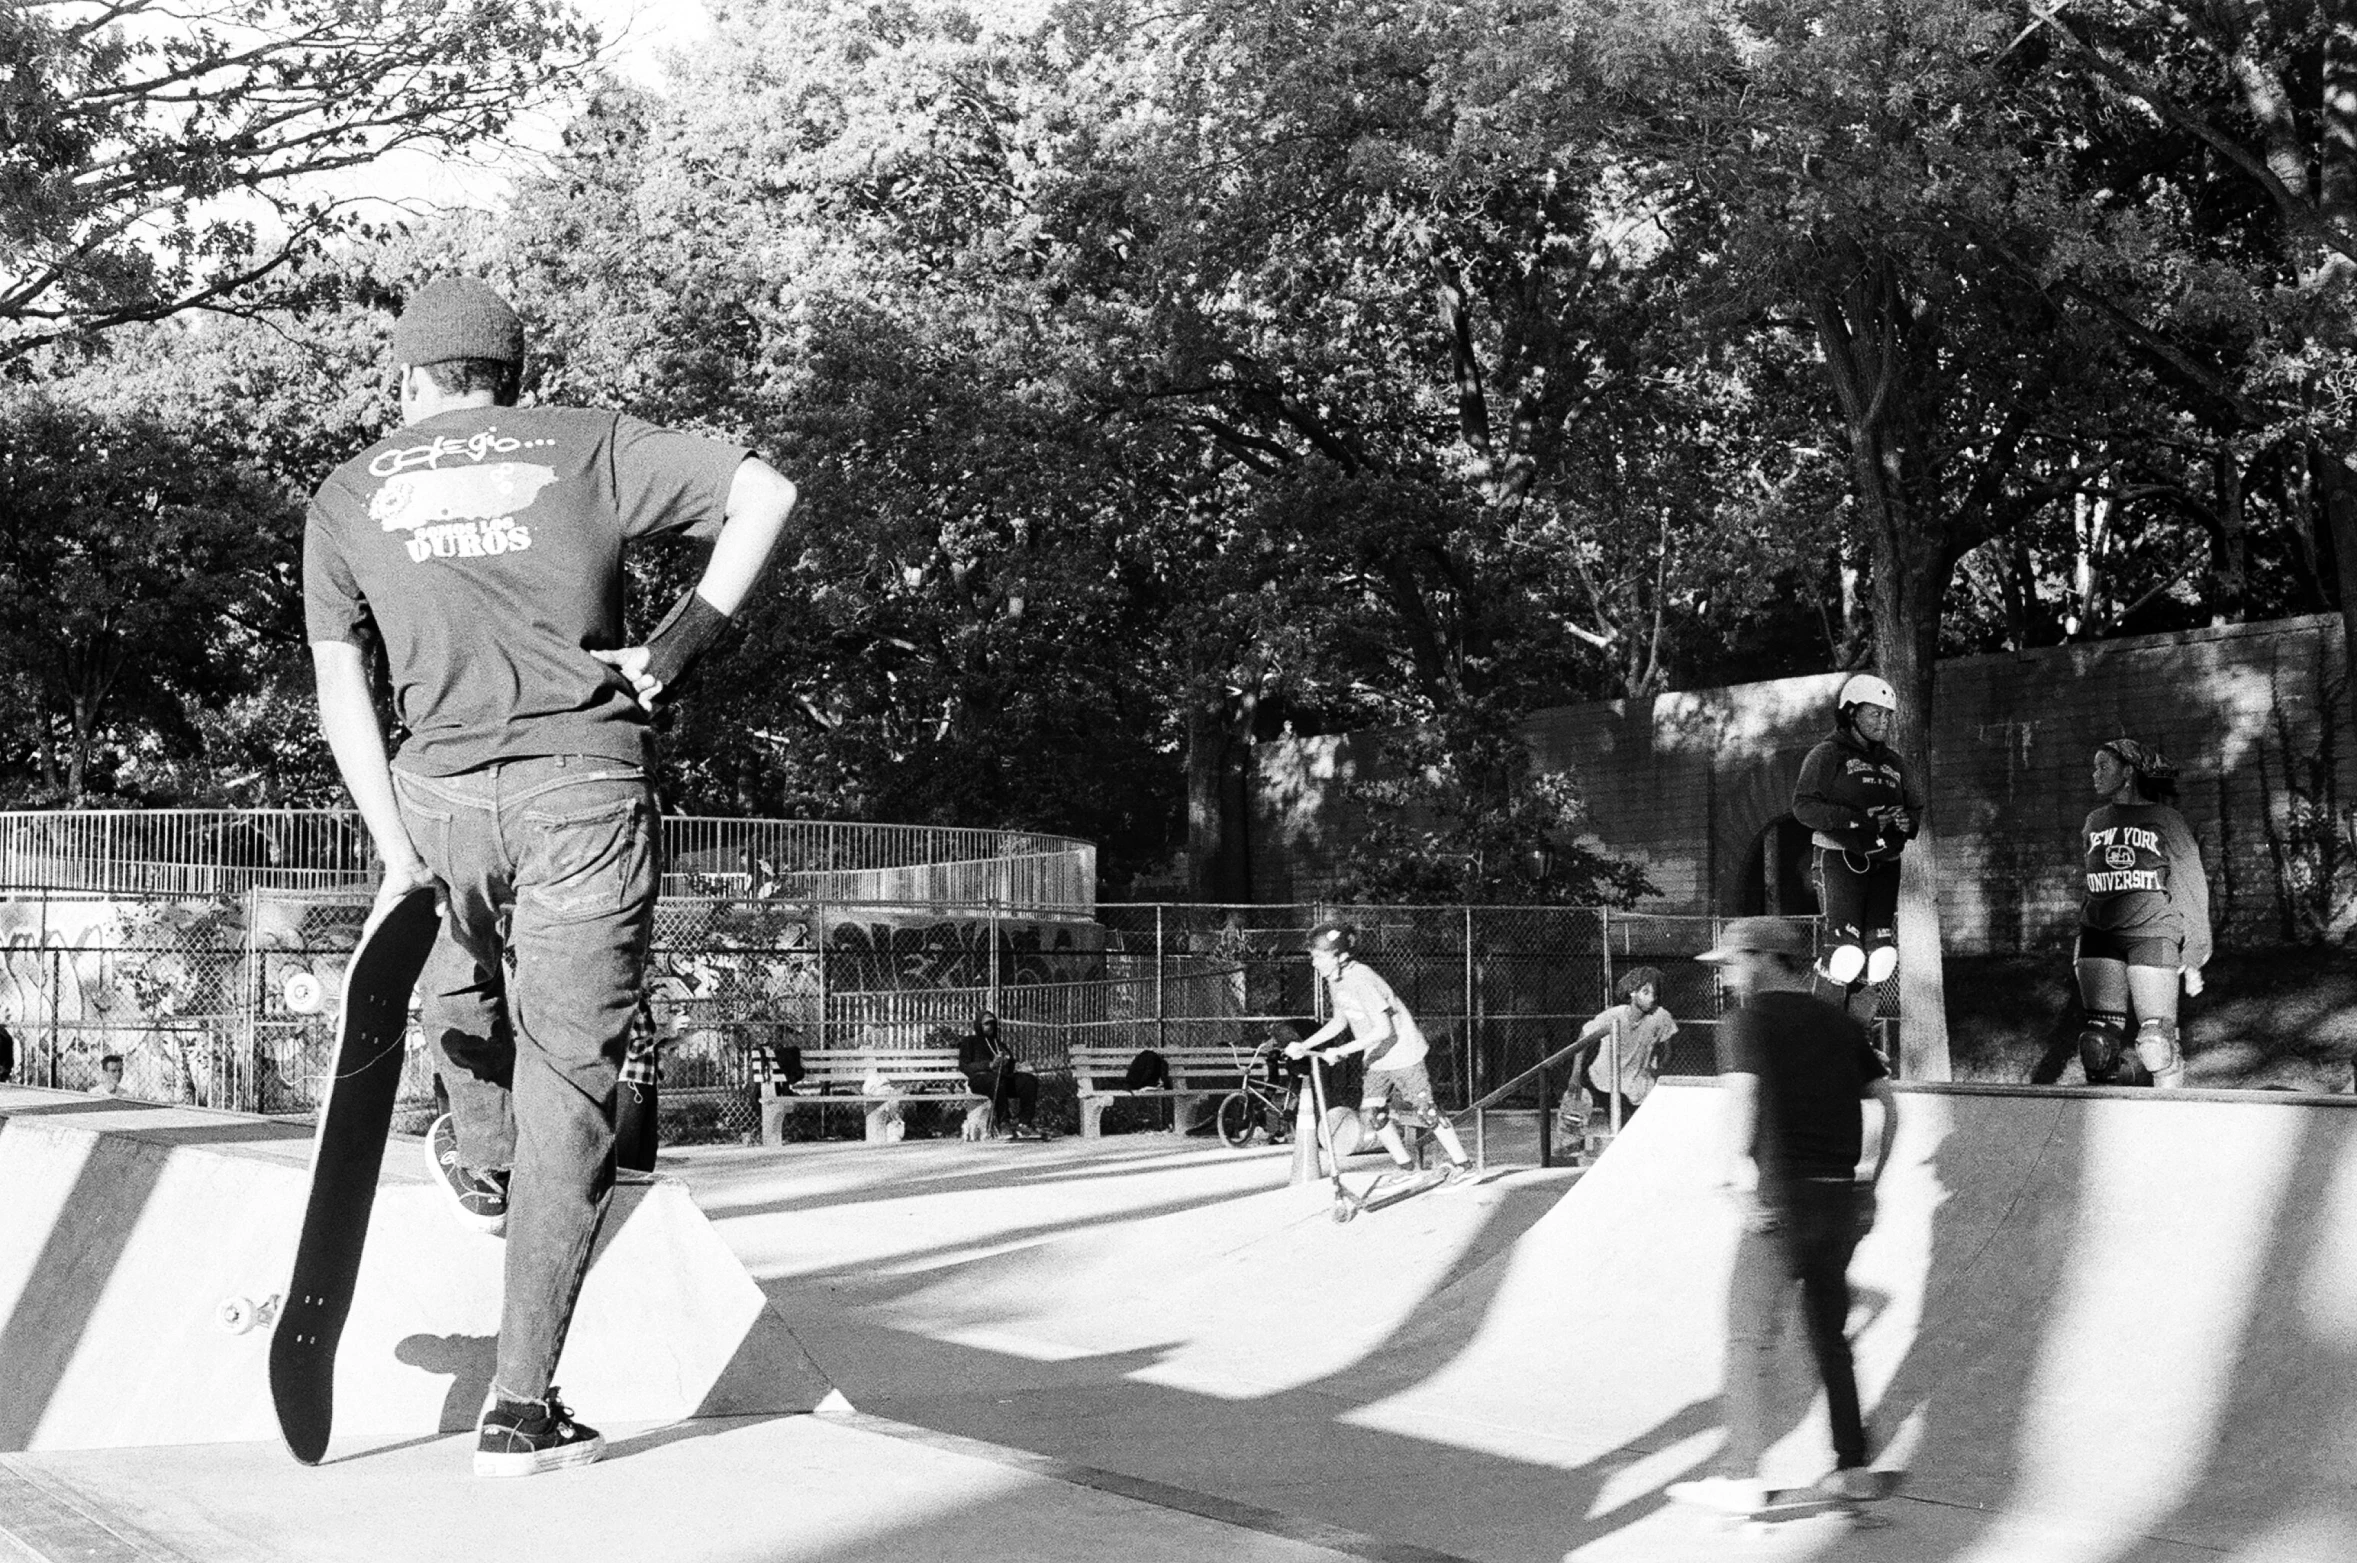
[1791,672,1923,992]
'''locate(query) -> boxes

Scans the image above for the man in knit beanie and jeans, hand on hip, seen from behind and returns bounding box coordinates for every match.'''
[304,276,794,1476]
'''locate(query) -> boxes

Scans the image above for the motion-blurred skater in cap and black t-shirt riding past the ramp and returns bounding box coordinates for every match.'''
[1669,917,1897,1513]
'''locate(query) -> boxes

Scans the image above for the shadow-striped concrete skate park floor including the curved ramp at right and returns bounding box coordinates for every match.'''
[0,1087,2357,1563]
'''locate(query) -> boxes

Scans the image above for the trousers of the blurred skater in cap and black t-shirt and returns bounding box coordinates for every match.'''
[1721,1179,1867,1480]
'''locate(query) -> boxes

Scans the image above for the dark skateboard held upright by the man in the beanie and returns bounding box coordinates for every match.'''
[271,891,441,1466]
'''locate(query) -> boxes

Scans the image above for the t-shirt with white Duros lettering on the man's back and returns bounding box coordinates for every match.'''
[304,408,745,776]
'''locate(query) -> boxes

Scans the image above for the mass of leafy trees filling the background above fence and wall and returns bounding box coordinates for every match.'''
[13,0,2357,1000]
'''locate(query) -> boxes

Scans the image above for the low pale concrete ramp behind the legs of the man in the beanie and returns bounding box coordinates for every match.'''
[0,1087,827,1450]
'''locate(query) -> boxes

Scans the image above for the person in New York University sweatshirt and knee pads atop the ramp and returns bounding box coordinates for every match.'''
[2072,738,2211,1089]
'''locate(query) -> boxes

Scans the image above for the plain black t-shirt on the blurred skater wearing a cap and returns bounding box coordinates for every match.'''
[1718,990,1890,1186]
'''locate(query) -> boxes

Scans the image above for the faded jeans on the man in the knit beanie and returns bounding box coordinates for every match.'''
[394,754,660,1400]
